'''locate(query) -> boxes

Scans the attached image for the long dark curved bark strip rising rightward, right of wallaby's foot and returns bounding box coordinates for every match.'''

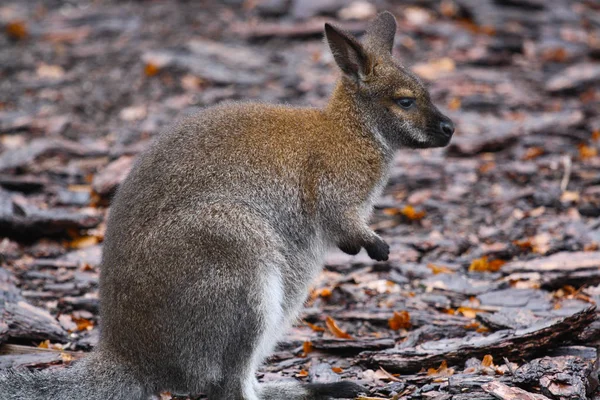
[358,306,596,372]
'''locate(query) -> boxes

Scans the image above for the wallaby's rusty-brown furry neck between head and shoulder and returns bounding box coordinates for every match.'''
[325,78,393,159]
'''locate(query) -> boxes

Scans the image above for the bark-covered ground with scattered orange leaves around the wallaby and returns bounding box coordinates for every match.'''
[0,0,600,400]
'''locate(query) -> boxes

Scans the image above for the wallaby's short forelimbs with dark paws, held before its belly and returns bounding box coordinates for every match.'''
[337,213,390,261]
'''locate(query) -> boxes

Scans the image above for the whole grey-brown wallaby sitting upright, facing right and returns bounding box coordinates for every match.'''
[0,12,454,400]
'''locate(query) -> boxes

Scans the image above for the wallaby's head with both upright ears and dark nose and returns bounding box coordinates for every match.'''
[325,12,454,148]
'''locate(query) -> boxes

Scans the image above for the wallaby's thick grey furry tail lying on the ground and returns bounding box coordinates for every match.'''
[0,353,150,400]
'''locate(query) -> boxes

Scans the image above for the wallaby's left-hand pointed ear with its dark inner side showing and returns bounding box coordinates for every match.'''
[325,23,370,80]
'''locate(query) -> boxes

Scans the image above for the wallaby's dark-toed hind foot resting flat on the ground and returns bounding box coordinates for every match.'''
[259,381,367,400]
